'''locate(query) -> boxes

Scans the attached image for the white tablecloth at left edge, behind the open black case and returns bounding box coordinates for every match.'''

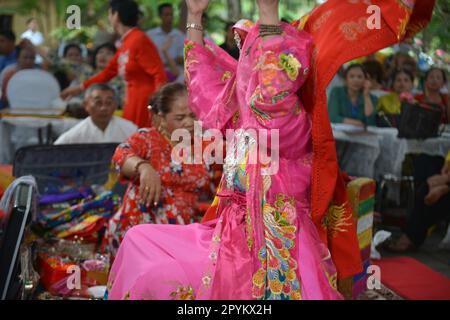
[0,117,81,163]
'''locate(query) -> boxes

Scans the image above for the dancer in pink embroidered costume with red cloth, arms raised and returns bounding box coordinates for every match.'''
[108,0,434,300]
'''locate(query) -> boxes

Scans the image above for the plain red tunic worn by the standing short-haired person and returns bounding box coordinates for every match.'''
[83,28,167,128]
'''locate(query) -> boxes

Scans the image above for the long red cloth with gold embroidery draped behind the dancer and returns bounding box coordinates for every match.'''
[293,0,435,278]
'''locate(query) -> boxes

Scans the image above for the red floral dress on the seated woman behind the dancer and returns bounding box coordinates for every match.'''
[104,128,211,253]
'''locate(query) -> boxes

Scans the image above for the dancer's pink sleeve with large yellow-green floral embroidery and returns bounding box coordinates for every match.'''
[245,24,312,118]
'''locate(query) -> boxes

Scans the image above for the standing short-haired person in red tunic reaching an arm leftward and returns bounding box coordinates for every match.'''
[61,0,167,128]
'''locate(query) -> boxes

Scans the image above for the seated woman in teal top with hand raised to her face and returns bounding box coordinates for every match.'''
[328,64,377,127]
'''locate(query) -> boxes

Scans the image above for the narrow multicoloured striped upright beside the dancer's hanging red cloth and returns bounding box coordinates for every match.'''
[347,178,376,299]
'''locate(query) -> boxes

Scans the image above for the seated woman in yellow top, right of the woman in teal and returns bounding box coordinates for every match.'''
[377,70,414,115]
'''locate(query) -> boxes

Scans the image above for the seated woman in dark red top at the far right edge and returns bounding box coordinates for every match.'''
[415,67,450,124]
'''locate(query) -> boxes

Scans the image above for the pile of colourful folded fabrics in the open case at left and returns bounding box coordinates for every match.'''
[33,187,121,299]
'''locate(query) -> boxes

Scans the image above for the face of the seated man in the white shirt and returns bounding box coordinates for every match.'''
[85,89,117,125]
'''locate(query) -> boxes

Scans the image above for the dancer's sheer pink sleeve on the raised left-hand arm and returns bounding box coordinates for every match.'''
[185,40,238,130]
